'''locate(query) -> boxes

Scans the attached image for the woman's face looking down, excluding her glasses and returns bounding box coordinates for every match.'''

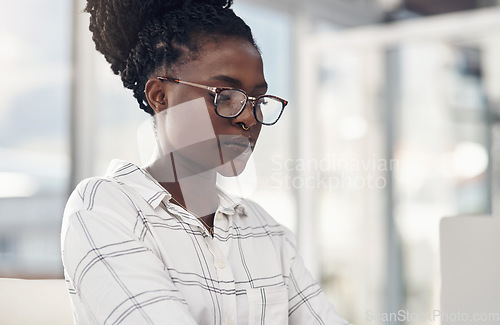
[149,38,267,178]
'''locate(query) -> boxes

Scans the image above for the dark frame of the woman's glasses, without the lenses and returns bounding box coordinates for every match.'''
[156,77,288,125]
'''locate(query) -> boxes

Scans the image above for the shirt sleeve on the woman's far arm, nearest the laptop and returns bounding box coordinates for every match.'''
[288,230,349,325]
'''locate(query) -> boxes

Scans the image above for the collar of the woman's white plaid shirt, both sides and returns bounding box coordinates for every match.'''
[106,159,246,216]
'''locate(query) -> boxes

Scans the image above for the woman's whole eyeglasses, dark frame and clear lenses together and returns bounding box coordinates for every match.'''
[157,77,288,125]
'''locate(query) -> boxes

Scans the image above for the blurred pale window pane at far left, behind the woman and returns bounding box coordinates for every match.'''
[0,0,71,277]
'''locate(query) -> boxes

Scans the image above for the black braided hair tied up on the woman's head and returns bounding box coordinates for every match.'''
[85,0,257,115]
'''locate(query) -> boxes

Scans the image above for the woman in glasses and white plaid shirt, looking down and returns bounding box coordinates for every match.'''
[61,0,346,324]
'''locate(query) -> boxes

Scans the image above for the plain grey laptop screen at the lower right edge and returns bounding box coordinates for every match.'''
[442,215,500,325]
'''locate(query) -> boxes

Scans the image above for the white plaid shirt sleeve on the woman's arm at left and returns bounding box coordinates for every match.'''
[61,178,196,325]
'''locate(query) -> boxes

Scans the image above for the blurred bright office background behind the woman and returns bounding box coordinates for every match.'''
[0,0,500,324]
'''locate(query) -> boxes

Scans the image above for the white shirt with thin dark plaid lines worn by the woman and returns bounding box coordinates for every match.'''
[61,161,347,325]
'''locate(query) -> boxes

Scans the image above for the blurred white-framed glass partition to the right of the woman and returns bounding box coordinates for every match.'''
[296,9,500,325]
